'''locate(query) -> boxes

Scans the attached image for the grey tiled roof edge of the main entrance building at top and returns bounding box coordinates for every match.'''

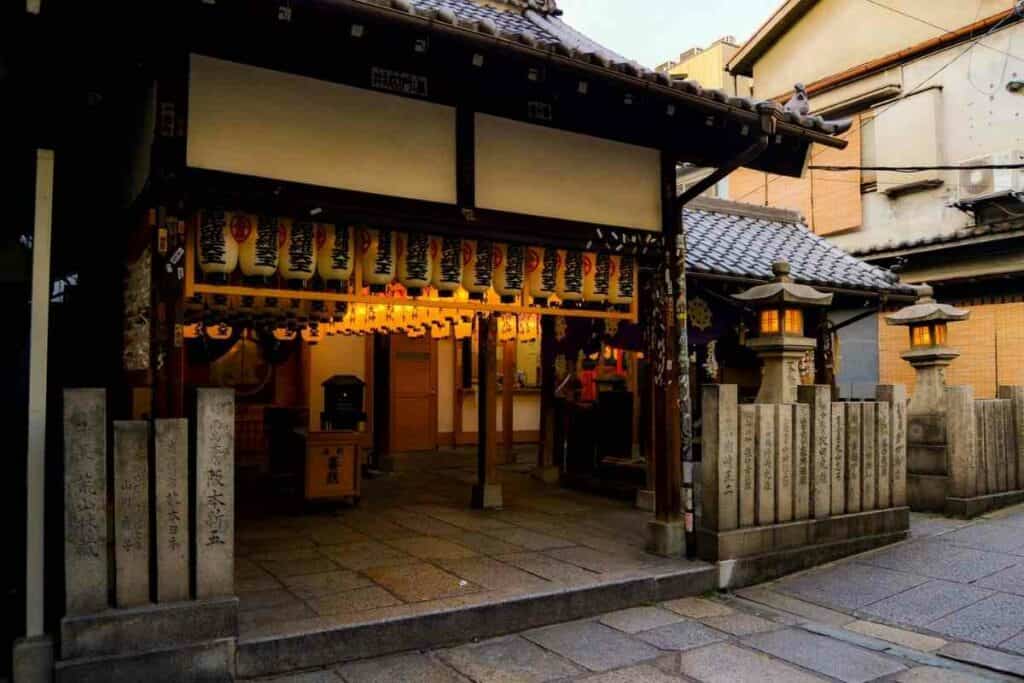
[356,0,850,135]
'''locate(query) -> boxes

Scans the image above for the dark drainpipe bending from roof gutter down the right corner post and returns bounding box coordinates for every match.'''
[666,114,777,558]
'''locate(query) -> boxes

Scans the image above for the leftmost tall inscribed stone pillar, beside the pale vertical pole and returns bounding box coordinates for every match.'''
[63,389,109,615]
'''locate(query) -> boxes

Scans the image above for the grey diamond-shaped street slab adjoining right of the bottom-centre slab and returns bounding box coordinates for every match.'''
[522,622,659,671]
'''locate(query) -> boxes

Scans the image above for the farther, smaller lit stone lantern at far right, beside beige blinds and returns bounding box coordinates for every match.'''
[886,285,971,415]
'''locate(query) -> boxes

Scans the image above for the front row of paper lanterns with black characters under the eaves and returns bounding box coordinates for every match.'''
[197,210,635,306]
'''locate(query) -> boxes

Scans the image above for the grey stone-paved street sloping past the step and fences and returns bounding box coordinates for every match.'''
[245,507,1024,683]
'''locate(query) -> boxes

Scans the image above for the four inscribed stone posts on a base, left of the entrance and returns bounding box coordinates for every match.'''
[56,389,238,681]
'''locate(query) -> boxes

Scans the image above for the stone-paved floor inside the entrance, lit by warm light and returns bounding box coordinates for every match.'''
[236,447,698,642]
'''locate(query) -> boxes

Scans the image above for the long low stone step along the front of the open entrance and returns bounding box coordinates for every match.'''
[237,562,717,679]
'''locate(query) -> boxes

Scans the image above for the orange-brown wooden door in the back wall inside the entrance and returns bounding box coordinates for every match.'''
[389,335,437,453]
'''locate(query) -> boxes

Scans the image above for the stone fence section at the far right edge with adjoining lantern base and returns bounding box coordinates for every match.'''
[937,386,1024,517]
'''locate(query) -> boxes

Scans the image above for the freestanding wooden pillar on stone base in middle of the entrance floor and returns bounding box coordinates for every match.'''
[472,314,502,509]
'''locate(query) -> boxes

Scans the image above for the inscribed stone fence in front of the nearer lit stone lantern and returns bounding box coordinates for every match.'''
[697,385,909,588]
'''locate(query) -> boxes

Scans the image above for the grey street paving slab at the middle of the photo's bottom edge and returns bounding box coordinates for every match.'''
[438,636,582,683]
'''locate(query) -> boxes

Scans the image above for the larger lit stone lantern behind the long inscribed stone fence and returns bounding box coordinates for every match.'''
[733,261,833,403]
